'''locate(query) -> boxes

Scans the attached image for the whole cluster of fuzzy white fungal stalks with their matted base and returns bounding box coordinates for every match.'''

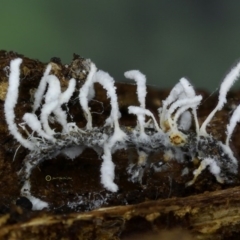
[4,58,240,209]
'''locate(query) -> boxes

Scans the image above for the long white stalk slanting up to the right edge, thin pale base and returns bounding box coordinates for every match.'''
[200,62,240,136]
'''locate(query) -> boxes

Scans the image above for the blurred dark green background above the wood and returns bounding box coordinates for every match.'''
[0,0,240,91]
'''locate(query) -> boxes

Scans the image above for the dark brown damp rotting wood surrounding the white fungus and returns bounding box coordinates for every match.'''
[0,51,240,239]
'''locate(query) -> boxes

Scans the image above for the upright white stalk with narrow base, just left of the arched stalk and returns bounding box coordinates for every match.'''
[79,62,97,130]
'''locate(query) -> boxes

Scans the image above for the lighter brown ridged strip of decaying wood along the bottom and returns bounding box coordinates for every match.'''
[0,187,240,240]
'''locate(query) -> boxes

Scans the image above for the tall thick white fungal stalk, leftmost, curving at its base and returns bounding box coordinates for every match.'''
[4,58,35,150]
